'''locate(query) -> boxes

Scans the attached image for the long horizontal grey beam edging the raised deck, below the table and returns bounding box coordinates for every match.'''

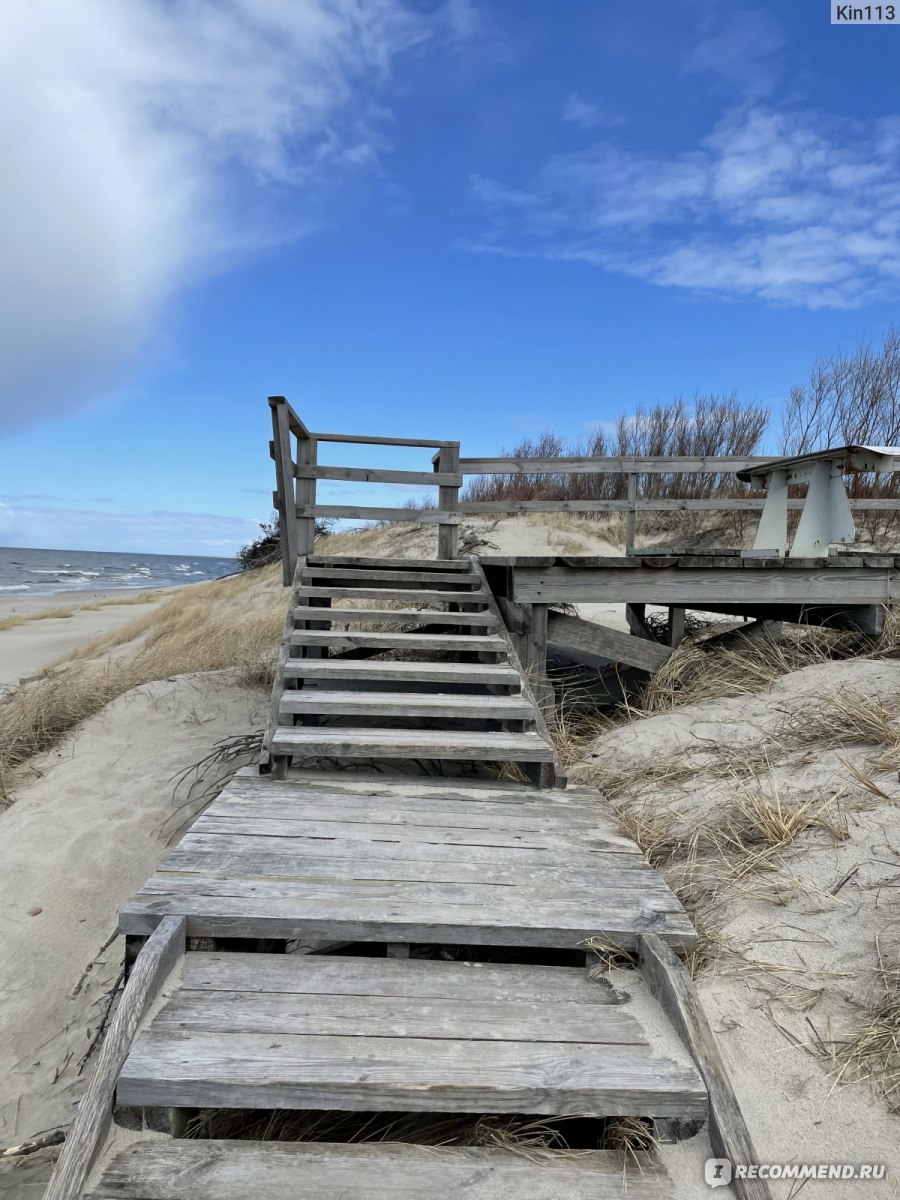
[514,566,900,608]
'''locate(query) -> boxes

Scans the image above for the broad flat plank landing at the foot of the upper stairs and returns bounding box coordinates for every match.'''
[120,768,696,945]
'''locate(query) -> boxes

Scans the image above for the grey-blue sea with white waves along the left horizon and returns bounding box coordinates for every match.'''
[0,546,240,599]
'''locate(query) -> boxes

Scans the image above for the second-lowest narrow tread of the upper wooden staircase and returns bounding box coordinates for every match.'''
[280,688,534,721]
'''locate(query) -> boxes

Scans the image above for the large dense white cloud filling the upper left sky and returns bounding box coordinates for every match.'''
[0,0,427,426]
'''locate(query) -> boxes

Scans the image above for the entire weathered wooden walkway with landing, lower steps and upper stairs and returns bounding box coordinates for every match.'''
[48,559,764,1200]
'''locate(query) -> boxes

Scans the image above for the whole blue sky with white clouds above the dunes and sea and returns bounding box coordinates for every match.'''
[0,0,900,556]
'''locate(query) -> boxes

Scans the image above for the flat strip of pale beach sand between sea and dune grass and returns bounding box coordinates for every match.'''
[0,584,172,694]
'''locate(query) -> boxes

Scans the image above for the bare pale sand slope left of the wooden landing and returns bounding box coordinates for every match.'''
[0,672,268,1200]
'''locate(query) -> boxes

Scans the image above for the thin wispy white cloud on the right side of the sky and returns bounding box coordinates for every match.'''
[470,106,900,308]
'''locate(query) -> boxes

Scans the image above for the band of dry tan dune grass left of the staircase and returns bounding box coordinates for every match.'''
[0,568,284,803]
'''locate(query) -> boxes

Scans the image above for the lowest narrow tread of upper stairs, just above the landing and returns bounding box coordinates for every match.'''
[271,726,553,762]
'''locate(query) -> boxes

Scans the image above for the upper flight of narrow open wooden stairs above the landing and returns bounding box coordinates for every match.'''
[263,557,564,787]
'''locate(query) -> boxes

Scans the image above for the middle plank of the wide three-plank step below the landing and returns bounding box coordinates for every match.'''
[152,988,648,1046]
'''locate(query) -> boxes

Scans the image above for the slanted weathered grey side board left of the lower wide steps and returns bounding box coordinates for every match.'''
[44,917,186,1200]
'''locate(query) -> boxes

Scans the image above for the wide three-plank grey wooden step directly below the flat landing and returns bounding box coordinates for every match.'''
[116,952,707,1118]
